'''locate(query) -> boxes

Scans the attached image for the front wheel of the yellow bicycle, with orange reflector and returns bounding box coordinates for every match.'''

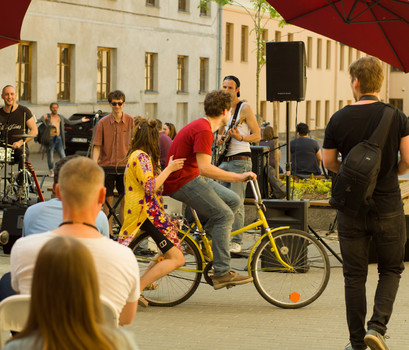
[251,229,330,309]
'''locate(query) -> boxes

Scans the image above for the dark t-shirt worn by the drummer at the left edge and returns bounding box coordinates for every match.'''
[0,105,33,144]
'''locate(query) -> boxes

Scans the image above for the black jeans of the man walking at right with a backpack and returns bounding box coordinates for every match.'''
[338,210,406,349]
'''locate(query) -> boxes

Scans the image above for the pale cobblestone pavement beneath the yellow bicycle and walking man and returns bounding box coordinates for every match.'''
[0,150,409,350]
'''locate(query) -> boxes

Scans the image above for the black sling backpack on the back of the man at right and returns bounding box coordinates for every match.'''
[329,105,395,217]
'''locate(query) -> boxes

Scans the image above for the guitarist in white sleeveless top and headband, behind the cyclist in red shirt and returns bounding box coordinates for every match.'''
[217,75,261,253]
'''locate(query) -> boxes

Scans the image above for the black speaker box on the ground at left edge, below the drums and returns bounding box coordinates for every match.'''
[1,207,27,254]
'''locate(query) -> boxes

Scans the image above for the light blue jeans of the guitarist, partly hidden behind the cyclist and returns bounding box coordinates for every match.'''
[219,159,252,244]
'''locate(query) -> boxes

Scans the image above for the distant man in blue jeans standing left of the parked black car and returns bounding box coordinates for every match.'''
[38,102,89,177]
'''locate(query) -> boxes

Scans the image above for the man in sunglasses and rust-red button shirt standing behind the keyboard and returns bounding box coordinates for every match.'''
[92,90,134,234]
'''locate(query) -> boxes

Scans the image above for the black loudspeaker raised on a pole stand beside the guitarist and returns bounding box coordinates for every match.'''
[266,41,307,101]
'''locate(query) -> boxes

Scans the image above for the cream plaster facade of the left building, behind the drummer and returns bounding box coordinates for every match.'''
[0,0,217,128]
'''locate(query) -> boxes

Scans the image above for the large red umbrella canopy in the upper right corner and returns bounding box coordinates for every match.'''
[268,0,409,72]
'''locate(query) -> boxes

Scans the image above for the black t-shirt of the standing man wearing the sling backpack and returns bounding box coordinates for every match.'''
[323,102,409,213]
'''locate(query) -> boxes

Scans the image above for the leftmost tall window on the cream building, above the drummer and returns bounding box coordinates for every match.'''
[16,42,31,101]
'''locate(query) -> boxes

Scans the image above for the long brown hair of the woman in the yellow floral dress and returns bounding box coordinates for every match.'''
[128,118,161,174]
